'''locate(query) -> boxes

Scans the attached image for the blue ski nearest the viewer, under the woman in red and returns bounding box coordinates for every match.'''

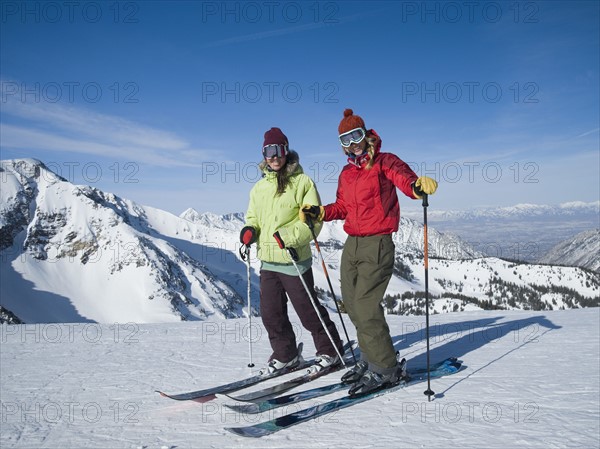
[225,359,462,438]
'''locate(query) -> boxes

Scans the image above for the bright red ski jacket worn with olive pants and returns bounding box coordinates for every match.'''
[323,129,417,237]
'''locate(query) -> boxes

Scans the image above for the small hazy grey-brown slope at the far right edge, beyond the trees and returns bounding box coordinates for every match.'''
[539,229,600,271]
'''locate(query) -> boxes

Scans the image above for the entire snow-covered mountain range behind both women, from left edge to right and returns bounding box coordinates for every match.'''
[0,160,600,323]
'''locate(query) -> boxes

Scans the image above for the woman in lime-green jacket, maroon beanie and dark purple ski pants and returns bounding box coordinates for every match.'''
[240,128,342,372]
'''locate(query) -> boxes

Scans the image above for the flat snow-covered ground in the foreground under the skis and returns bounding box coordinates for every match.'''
[0,308,600,448]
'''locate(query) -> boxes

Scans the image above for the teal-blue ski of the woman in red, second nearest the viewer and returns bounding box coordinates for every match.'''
[225,358,456,414]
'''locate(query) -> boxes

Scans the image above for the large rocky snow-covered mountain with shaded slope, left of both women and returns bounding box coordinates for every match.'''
[0,160,245,322]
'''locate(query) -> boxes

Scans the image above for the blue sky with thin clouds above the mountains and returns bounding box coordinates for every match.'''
[0,1,600,214]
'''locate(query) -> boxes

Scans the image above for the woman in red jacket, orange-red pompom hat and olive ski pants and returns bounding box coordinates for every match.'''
[302,109,437,394]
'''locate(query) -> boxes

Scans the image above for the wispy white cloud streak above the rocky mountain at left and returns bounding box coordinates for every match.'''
[0,82,218,167]
